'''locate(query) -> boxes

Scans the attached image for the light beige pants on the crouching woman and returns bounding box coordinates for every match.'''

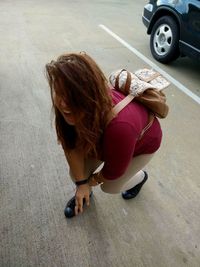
[70,153,155,194]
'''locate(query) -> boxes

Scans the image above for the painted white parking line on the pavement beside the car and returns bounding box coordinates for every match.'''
[99,24,200,104]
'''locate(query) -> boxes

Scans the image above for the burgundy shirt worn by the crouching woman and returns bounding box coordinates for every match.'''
[102,90,162,180]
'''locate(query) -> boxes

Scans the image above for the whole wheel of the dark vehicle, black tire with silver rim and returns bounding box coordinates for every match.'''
[150,16,180,63]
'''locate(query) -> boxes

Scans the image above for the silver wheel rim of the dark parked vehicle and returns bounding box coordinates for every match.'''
[153,24,173,56]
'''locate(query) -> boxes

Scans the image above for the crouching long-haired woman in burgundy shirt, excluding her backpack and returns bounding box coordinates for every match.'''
[46,53,162,218]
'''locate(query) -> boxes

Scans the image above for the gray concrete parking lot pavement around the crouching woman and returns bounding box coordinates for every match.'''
[0,0,200,267]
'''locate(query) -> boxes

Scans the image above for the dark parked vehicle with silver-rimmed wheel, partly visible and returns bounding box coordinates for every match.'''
[142,0,200,63]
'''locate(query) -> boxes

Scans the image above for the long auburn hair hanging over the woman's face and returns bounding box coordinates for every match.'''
[46,53,112,155]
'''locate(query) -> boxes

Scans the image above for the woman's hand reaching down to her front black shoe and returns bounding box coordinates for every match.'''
[75,184,91,215]
